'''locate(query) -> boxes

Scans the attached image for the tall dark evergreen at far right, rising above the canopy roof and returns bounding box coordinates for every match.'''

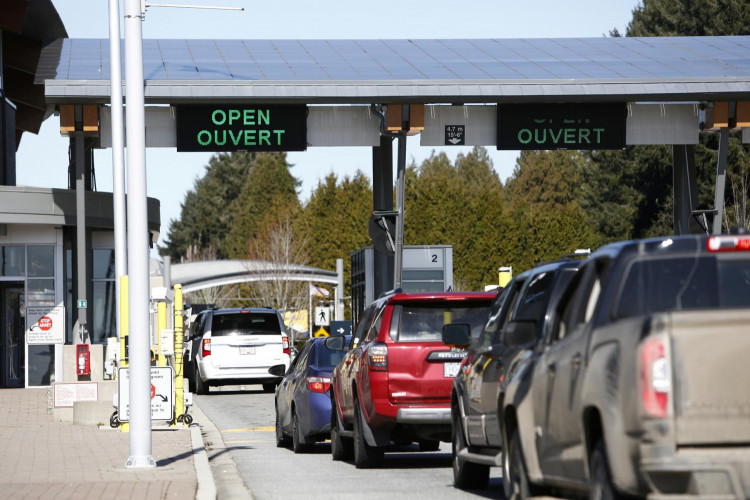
[582,0,750,241]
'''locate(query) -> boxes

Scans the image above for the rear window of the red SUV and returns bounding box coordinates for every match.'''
[390,303,490,342]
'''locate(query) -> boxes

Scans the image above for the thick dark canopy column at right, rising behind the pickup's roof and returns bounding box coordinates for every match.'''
[672,144,708,236]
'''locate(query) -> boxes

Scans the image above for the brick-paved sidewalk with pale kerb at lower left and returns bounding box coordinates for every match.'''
[0,388,249,500]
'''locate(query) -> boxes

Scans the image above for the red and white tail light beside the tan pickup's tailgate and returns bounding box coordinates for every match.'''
[640,338,672,418]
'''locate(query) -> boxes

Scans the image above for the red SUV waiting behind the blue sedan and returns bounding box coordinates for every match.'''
[330,291,496,468]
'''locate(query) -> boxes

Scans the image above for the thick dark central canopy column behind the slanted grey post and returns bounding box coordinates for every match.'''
[372,136,393,297]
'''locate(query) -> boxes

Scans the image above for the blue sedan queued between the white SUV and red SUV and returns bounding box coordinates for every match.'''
[275,337,350,453]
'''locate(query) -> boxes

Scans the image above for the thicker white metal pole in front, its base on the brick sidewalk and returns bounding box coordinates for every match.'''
[125,0,156,468]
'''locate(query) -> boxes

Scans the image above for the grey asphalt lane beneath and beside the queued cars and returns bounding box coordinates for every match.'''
[195,385,503,500]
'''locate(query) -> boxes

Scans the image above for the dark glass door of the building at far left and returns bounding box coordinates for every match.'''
[0,282,26,387]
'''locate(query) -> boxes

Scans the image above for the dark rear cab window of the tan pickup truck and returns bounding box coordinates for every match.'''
[616,256,750,318]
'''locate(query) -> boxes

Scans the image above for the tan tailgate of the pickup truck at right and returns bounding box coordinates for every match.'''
[670,309,750,446]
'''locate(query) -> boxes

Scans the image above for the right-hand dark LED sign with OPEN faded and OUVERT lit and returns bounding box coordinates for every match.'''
[497,103,627,150]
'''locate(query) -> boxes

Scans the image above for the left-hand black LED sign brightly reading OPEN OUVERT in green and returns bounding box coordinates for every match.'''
[175,104,307,152]
